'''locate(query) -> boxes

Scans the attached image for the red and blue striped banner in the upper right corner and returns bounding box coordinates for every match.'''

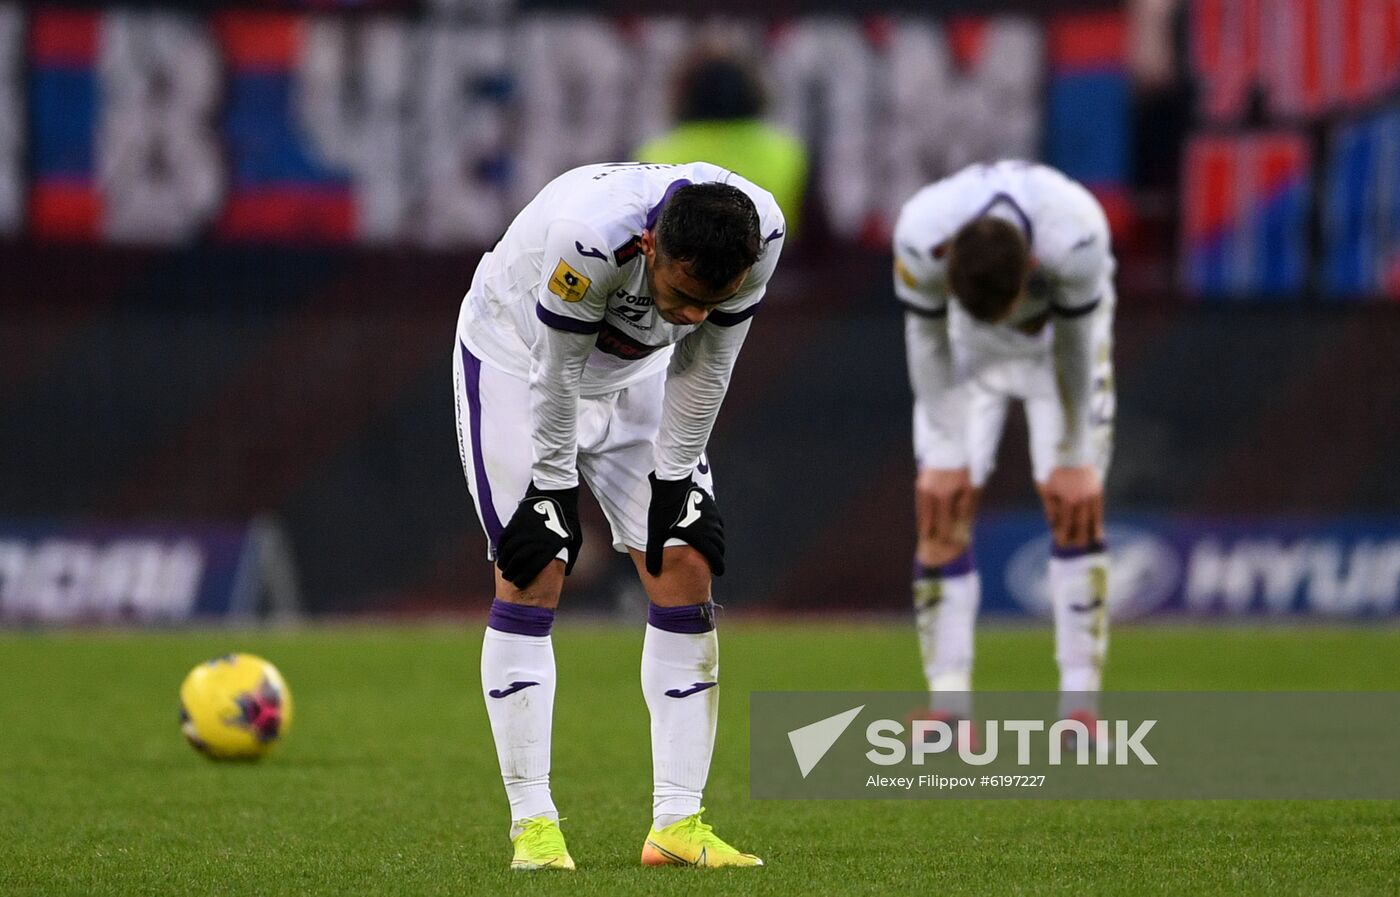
[1179,0,1400,302]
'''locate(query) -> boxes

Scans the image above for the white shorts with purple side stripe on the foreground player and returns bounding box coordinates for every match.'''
[452,340,714,561]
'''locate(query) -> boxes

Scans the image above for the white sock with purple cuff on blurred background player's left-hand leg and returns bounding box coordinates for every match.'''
[914,551,981,718]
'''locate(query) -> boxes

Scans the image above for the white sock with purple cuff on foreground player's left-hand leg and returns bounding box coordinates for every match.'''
[482,599,559,837]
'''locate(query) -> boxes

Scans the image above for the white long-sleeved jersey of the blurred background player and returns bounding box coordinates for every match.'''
[893,161,1116,474]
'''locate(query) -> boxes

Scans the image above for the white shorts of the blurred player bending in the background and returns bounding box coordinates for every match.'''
[914,302,1114,488]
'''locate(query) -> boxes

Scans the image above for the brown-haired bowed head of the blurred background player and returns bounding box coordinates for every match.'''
[948,216,1030,323]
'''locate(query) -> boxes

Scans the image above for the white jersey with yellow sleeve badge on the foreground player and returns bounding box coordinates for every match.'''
[458,162,785,488]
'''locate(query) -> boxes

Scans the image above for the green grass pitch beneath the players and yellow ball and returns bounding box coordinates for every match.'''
[0,612,1400,897]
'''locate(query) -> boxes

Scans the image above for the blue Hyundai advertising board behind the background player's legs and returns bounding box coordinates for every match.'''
[976,514,1400,620]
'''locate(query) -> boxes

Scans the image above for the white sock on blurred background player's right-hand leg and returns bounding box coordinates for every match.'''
[1050,549,1109,716]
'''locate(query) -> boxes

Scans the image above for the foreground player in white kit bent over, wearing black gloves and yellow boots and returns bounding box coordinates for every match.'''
[454,162,784,869]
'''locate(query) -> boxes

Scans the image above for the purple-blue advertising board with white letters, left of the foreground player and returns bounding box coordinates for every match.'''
[0,519,297,626]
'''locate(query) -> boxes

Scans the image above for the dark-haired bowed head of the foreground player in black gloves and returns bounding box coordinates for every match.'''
[641,183,763,325]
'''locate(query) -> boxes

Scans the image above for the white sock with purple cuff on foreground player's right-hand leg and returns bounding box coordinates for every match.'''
[641,602,720,828]
